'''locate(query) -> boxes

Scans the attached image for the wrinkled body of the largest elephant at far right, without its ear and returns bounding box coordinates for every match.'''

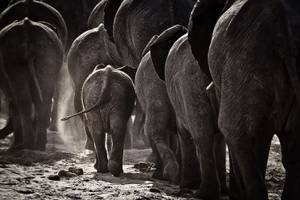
[208,0,300,200]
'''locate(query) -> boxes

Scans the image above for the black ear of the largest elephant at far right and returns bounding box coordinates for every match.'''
[188,0,225,79]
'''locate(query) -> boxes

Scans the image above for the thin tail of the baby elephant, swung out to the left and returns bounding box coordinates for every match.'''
[61,66,113,121]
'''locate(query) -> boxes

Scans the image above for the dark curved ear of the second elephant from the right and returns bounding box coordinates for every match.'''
[150,25,187,81]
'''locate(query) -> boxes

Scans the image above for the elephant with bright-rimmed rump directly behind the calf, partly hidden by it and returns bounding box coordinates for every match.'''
[67,24,120,149]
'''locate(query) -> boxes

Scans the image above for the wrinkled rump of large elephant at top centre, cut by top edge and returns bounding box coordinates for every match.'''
[111,0,195,68]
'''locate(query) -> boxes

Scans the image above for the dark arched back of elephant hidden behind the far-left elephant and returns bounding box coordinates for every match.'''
[0,0,68,46]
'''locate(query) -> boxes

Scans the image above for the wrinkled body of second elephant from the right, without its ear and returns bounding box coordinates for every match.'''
[165,34,227,199]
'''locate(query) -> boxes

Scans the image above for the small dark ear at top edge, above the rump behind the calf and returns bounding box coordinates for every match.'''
[104,0,123,41]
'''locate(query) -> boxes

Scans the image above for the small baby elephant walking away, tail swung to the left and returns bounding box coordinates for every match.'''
[62,65,135,176]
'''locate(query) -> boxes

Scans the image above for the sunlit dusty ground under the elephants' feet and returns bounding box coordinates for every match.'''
[0,116,284,200]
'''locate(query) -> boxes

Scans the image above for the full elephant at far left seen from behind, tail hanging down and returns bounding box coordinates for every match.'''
[0,18,64,150]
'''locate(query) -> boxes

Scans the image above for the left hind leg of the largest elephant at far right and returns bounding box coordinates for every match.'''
[226,130,268,200]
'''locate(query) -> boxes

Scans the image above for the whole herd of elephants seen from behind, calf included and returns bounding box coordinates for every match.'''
[0,0,300,200]
